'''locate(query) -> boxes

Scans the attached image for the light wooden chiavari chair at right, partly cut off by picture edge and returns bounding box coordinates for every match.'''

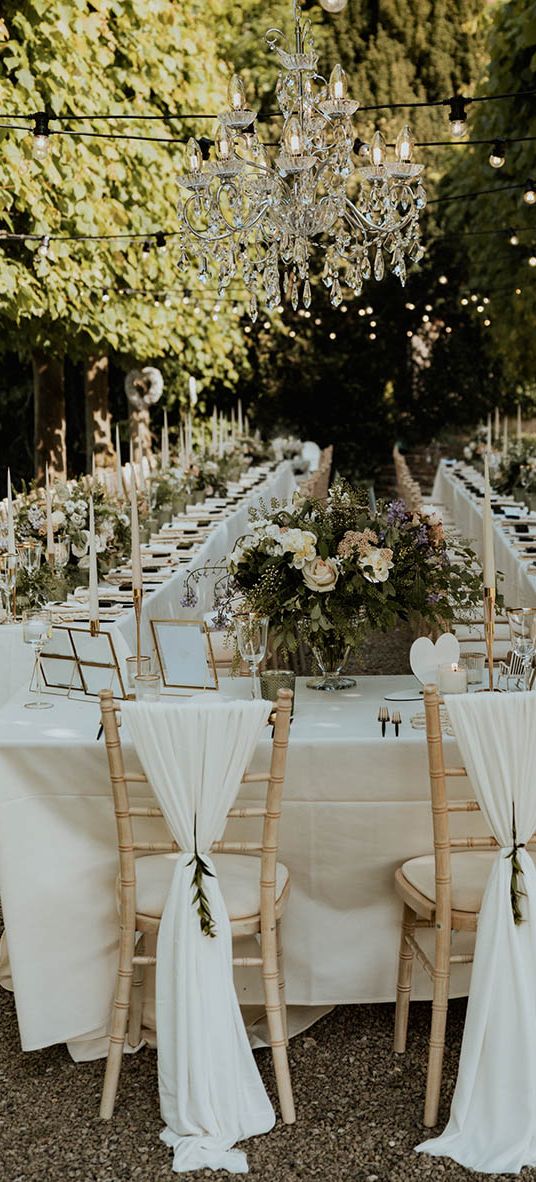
[394,686,535,1128]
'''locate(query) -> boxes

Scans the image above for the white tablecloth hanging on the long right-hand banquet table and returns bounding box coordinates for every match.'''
[432,460,536,608]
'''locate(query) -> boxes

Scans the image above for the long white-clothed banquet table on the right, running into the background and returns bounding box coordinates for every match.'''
[432,460,536,608]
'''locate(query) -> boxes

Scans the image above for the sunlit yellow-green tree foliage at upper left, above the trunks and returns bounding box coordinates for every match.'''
[0,0,244,392]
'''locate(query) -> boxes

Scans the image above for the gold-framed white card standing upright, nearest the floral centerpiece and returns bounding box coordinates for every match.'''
[150,619,218,689]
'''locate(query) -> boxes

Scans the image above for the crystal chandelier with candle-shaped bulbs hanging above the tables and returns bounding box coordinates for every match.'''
[177,0,426,320]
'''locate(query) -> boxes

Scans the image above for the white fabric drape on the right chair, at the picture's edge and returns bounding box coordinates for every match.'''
[418,694,536,1174]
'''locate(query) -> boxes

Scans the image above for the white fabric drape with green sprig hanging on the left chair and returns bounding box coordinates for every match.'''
[123,700,275,1174]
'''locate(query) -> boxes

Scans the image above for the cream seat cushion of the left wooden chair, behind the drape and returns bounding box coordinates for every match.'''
[136,853,289,920]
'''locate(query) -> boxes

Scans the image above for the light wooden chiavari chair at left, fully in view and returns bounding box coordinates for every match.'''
[99,689,296,1124]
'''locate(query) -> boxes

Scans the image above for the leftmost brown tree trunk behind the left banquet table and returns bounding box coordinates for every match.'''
[32,350,67,481]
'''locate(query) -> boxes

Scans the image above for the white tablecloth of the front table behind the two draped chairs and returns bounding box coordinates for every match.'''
[0,677,478,1050]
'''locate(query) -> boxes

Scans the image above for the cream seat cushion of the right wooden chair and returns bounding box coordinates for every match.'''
[402,850,536,911]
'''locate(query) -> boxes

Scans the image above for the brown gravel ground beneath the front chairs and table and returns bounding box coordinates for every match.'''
[0,991,536,1182]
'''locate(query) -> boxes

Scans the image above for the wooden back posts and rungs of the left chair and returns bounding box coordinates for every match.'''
[99,689,292,918]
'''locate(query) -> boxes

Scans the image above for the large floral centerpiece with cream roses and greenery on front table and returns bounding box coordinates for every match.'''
[227,481,482,676]
